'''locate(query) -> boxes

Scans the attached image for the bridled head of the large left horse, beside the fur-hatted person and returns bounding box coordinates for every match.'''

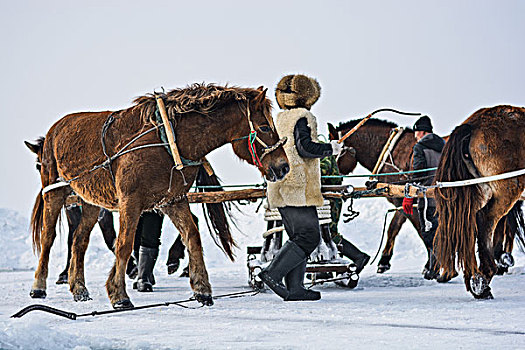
[232,86,290,182]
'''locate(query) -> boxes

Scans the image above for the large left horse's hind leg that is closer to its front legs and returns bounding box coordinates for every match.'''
[69,203,99,301]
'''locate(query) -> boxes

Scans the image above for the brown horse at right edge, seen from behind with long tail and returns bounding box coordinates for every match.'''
[434,106,525,299]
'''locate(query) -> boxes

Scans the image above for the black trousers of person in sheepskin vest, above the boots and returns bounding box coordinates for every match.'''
[279,206,321,256]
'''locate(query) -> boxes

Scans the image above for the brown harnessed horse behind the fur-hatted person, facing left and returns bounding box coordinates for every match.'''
[328,118,428,273]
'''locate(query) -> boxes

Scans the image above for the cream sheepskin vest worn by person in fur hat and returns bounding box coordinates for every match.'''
[267,108,323,208]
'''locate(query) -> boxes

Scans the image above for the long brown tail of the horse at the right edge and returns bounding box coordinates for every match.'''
[434,124,482,276]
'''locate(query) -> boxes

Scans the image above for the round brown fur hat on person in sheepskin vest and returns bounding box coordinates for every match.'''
[275,74,321,110]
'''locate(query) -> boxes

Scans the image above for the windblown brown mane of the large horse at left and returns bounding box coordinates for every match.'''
[132,83,272,122]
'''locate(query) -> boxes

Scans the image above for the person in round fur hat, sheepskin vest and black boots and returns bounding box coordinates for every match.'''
[258,75,342,301]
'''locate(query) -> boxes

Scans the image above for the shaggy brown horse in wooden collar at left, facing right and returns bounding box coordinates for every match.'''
[32,84,289,308]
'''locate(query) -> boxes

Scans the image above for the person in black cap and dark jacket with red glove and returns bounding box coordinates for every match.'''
[403,115,445,282]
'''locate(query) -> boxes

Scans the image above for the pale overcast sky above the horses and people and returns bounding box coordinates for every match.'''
[0,0,525,216]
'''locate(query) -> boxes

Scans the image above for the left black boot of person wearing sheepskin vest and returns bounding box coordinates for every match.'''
[258,241,306,300]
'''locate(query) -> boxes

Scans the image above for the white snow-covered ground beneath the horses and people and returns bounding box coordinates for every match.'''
[0,199,525,349]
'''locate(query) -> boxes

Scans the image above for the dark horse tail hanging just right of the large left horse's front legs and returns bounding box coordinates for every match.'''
[196,165,237,261]
